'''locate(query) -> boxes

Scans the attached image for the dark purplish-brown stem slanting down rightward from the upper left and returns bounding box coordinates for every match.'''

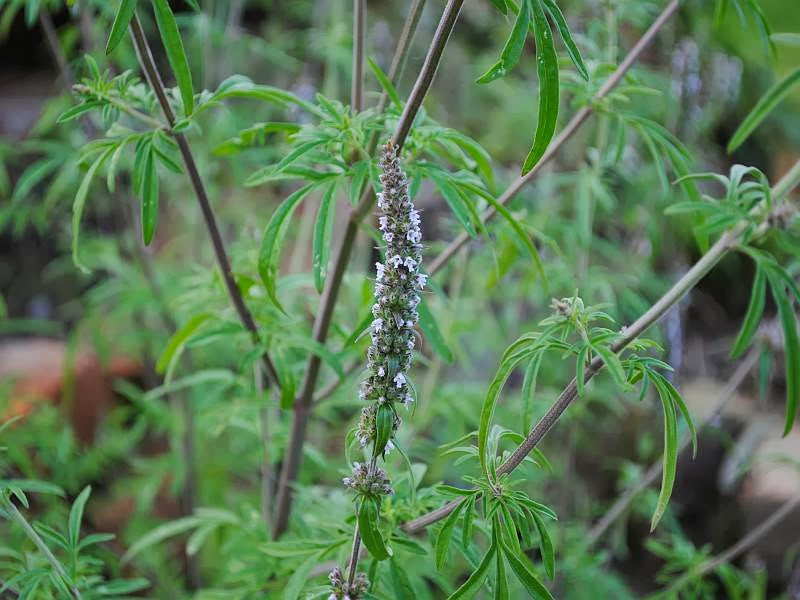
[130,15,280,388]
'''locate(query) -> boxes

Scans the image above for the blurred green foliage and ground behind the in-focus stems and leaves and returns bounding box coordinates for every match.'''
[0,0,800,599]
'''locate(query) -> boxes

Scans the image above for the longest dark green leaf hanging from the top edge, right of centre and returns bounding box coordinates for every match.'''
[522,0,558,175]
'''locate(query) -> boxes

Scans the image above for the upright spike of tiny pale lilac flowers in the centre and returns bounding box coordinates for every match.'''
[330,141,426,600]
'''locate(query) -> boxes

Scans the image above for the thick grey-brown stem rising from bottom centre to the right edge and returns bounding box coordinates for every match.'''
[403,161,800,533]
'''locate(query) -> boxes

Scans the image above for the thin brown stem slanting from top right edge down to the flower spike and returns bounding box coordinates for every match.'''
[428,0,680,275]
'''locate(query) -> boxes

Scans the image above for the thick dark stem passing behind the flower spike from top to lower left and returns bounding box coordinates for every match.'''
[273,0,464,538]
